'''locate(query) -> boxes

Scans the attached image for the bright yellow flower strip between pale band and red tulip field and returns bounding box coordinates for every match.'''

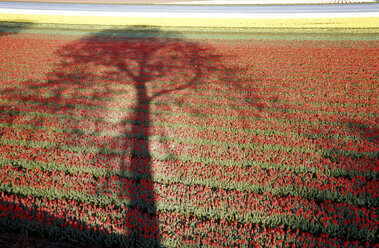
[0,13,379,33]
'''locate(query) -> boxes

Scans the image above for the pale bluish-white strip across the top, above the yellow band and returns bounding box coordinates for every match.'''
[0,2,379,18]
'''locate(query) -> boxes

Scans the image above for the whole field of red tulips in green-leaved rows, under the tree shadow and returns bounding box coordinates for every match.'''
[0,23,379,247]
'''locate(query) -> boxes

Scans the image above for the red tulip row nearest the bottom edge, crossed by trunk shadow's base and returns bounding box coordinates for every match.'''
[0,194,372,247]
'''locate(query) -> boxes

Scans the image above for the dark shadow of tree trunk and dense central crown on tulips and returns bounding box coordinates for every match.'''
[63,29,219,247]
